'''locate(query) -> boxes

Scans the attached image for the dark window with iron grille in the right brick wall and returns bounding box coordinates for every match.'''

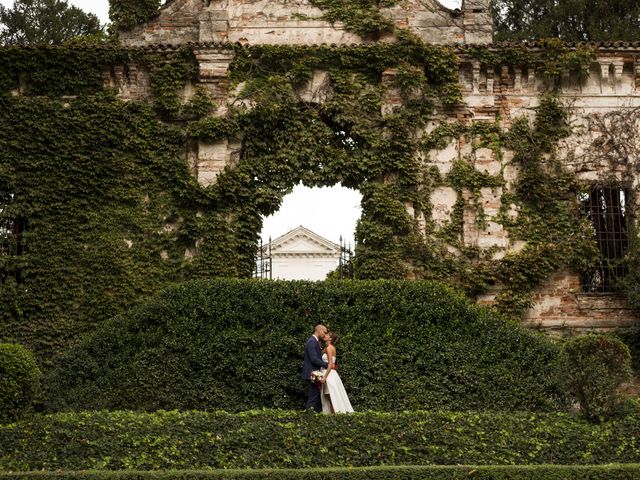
[580,185,629,293]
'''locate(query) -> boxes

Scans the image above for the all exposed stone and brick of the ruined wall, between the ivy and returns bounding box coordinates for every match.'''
[105,0,640,333]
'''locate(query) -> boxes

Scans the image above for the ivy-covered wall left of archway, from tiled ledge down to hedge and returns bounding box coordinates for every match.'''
[0,47,251,358]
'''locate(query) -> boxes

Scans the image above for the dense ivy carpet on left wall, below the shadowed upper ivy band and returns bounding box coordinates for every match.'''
[0,94,230,364]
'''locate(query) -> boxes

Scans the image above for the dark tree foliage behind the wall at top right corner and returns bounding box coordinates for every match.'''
[493,0,640,41]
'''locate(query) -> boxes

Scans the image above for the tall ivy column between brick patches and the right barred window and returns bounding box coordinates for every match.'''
[490,96,598,315]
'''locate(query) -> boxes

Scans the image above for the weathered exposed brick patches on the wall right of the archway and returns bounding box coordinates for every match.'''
[456,45,640,332]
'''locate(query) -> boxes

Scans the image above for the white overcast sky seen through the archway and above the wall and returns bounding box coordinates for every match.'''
[0,0,462,244]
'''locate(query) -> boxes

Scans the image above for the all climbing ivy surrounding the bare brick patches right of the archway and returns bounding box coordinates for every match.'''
[413,92,598,316]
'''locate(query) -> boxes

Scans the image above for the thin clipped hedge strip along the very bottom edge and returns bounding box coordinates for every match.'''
[0,465,640,480]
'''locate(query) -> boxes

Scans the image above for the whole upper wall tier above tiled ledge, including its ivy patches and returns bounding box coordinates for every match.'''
[111,0,492,46]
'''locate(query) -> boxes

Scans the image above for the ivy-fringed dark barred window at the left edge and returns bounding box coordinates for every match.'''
[0,194,27,284]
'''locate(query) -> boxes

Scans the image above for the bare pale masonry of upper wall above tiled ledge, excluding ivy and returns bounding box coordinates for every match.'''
[120,0,492,46]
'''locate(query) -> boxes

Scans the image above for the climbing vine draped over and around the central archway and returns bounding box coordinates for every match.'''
[212,43,460,278]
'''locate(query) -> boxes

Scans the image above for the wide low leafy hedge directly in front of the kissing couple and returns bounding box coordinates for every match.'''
[0,411,640,471]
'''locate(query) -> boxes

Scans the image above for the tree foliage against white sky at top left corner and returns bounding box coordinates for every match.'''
[0,0,102,45]
